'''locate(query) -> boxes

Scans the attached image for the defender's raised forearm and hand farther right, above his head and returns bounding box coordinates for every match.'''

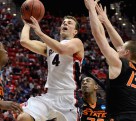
[96,4,124,50]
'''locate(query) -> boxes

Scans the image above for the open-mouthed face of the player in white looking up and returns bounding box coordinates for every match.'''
[60,19,77,39]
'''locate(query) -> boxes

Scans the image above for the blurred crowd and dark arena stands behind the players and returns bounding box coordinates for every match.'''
[0,0,136,121]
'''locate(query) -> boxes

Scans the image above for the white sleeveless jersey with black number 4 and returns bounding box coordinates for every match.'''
[45,40,83,90]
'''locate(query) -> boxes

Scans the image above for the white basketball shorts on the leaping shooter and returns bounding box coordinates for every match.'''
[22,90,78,121]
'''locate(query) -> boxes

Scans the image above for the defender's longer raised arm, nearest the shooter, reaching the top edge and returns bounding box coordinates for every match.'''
[84,0,121,68]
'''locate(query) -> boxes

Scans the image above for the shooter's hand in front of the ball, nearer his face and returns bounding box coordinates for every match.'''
[29,16,42,35]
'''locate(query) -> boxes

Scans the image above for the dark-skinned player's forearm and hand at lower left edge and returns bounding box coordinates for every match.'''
[0,101,23,113]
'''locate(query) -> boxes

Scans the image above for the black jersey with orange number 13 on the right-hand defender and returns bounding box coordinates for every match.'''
[106,58,136,116]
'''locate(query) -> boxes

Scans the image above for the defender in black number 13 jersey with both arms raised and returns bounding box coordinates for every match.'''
[84,0,136,121]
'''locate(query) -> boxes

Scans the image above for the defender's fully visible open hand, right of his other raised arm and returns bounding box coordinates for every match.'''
[96,4,108,23]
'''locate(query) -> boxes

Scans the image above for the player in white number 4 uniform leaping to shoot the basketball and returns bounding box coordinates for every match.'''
[17,16,84,121]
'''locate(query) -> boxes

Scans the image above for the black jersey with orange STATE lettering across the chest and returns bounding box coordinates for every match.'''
[80,101,107,121]
